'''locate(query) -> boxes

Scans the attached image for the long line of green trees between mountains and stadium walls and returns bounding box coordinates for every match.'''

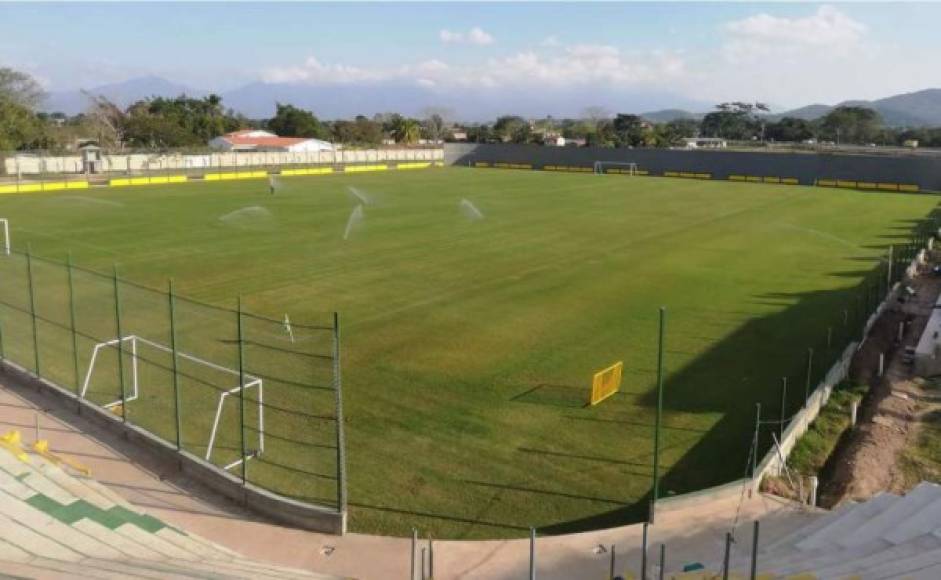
[0,68,941,150]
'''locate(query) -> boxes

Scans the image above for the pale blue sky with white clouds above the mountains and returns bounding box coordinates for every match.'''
[0,2,941,114]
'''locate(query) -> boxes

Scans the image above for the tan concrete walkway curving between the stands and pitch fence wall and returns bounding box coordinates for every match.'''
[0,374,820,580]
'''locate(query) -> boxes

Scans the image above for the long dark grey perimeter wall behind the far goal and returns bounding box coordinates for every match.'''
[444,143,941,191]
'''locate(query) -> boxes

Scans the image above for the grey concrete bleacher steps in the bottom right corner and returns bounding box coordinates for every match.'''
[674,482,941,580]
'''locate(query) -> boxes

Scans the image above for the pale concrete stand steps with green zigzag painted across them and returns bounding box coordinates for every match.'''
[0,430,348,580]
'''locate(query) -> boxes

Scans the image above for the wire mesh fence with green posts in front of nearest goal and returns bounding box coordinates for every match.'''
[0,252,346,512]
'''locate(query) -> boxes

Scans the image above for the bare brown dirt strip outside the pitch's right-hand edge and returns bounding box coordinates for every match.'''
[820,251,941,507]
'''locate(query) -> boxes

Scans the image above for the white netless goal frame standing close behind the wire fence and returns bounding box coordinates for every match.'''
[79,335,265,470]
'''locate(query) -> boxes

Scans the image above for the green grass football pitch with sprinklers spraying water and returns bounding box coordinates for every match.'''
[0,168,938,538]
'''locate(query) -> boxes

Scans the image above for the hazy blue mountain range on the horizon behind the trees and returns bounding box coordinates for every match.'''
[44,76,941,126]
